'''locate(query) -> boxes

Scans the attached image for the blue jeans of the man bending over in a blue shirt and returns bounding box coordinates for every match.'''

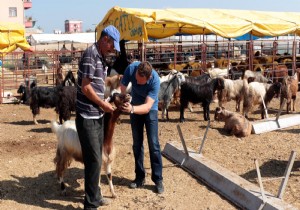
[130,110,163,183]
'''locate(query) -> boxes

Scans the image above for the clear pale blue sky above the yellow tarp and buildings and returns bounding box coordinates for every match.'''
[25,0,300,33]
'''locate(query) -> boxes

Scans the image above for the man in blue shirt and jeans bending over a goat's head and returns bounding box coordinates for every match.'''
[121,62,164,194]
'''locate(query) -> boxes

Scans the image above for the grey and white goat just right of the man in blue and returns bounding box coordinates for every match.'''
[158,73,184,120]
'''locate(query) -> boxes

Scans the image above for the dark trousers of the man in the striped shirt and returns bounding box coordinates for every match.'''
[75,114,104,208]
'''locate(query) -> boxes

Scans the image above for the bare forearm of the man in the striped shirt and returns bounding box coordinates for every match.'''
[81,78,114,112]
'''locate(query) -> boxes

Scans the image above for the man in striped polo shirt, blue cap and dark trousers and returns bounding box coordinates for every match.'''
[75,25,120,209]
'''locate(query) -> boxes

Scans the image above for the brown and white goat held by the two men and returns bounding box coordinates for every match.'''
[51,93,131,198]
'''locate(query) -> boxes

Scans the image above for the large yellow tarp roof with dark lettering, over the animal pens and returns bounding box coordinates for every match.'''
[96,6,300,41]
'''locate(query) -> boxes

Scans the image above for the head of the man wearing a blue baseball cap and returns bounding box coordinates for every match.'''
[98,25,120,56]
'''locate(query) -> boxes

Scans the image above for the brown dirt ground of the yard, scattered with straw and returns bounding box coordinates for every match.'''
[0,97,300,210]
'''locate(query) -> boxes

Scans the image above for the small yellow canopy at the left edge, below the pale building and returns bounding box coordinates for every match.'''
[0,22,30,54]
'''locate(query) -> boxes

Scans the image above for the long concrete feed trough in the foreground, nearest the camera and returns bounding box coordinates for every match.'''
[163,142,297,210]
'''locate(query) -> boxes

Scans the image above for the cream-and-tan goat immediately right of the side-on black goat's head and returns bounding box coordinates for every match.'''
[217,79,243,112]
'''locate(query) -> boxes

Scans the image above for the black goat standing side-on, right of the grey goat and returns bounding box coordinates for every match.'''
[180,78,224,122]
